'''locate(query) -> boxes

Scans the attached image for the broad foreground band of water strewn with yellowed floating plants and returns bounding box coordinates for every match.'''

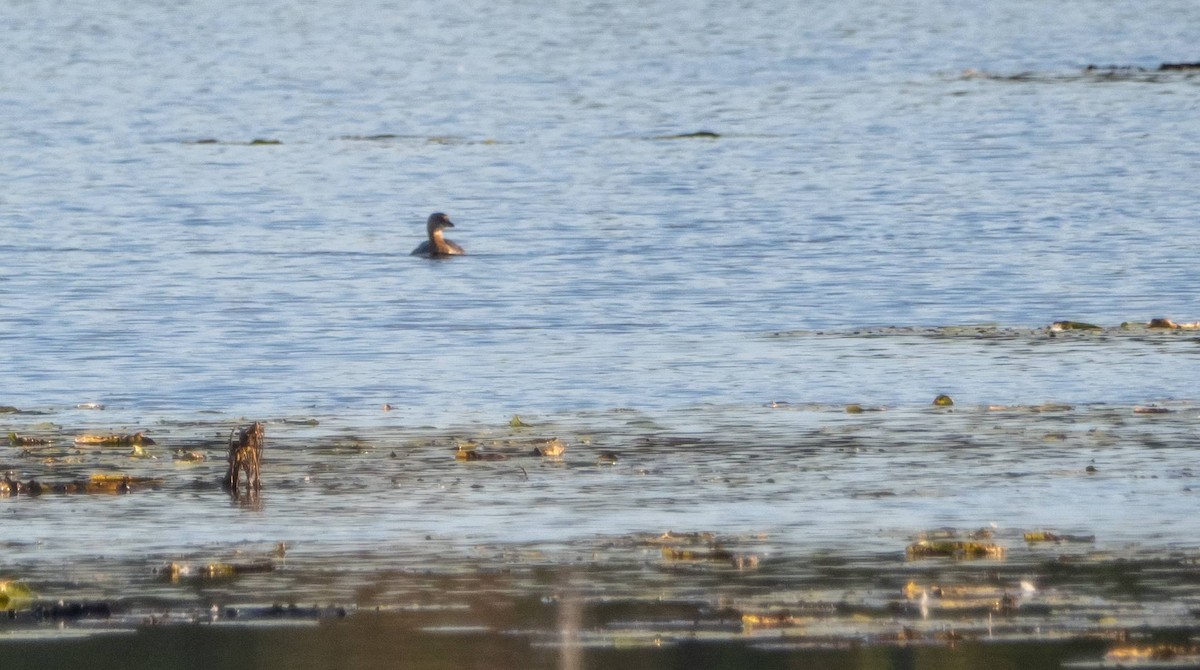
[0,396,1200,668]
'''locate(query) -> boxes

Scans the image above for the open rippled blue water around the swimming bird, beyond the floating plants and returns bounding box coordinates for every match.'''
[0,0,1200,424]
